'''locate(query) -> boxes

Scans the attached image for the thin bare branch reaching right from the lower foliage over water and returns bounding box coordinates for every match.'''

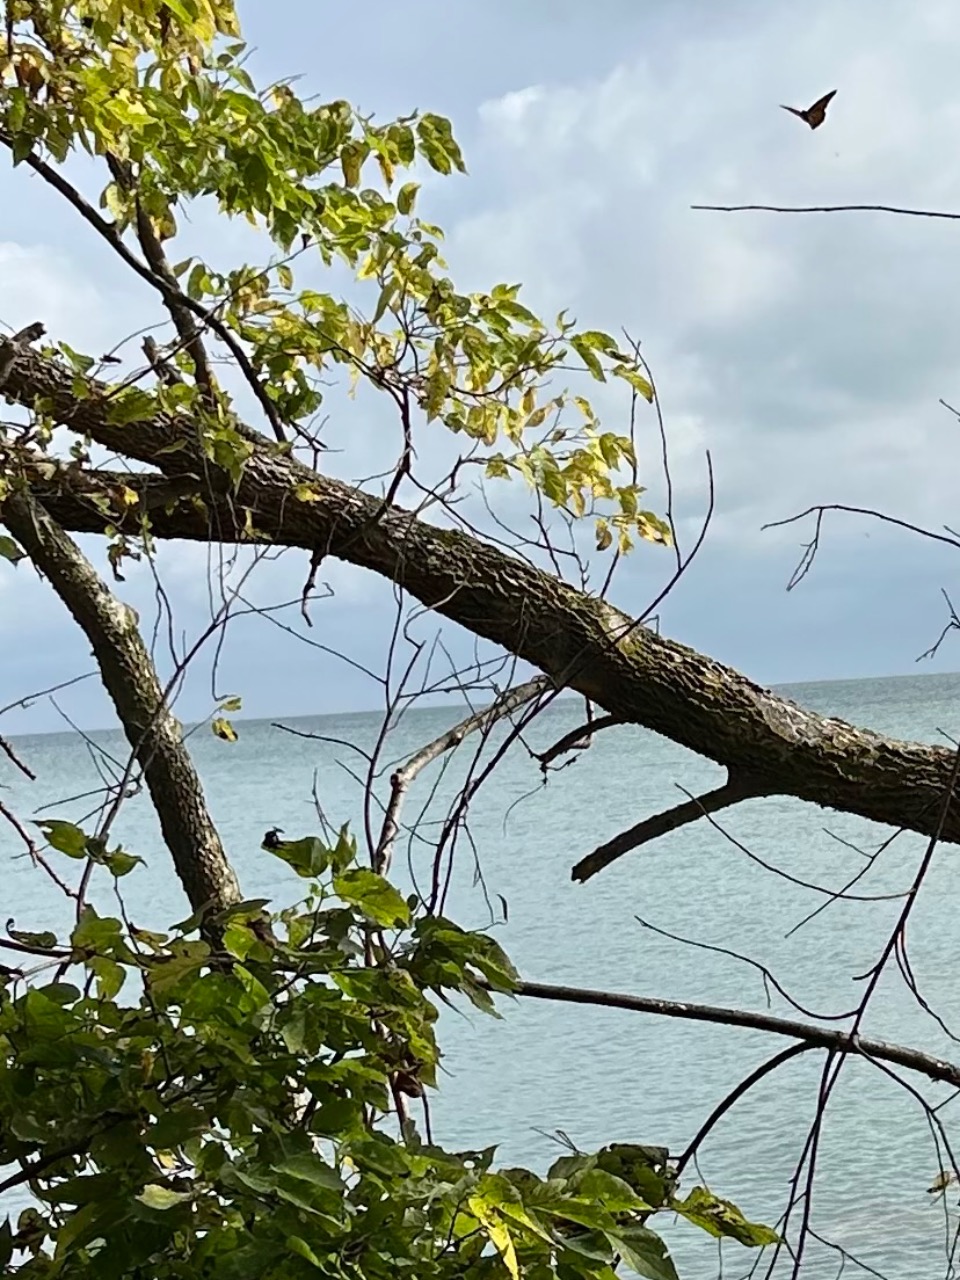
[506,982,960,1087]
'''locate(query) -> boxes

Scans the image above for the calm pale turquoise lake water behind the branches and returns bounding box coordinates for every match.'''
[0,676,960,1280]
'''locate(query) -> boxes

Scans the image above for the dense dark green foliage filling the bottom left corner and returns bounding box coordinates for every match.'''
[0,823,776,1280]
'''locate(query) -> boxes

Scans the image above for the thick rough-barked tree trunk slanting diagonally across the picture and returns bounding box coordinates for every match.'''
[4,349,960,842]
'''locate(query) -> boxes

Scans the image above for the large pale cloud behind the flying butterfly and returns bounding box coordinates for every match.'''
[452,4,960,563]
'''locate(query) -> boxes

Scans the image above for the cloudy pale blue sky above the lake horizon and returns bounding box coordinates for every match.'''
[0,0,960,733]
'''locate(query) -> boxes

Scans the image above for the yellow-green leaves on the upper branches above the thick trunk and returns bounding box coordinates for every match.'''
[0,0,671,550]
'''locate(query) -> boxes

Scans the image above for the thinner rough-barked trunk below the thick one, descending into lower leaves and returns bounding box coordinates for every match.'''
[0,483,239,911]
